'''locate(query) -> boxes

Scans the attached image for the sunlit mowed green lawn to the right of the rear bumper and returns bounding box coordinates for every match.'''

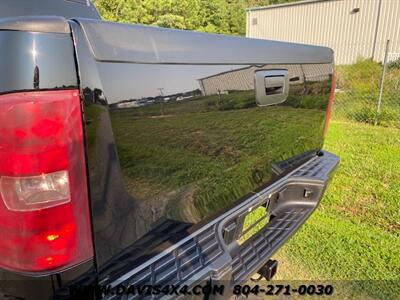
[277,122,400,299]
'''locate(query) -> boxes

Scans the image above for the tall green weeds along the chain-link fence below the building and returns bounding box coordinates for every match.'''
[334,59,400,128]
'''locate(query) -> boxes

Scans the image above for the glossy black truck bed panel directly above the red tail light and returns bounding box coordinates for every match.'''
[0,31,78,94]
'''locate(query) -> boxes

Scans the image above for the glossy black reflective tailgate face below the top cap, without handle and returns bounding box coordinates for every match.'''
[71,19,333,279]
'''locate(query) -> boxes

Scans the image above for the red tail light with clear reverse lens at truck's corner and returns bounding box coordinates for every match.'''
[0,90,93,273]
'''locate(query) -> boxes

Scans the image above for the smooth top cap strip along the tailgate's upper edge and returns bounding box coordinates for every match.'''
[76,18,333,65]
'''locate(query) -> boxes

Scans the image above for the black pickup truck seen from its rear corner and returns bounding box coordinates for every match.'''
[0,0,339,299]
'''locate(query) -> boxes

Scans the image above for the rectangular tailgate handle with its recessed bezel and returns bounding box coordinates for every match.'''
[255,69,289,106]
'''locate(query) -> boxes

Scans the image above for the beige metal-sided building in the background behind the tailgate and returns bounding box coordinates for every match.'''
[246,0,400,64]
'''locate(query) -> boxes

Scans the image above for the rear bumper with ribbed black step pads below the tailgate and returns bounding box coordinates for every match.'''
[101,151,339,299]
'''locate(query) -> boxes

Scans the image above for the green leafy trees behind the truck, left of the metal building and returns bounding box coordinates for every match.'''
[93,0,296,35]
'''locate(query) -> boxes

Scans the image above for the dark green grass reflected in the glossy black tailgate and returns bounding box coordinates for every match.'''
[111,99,324,222]
